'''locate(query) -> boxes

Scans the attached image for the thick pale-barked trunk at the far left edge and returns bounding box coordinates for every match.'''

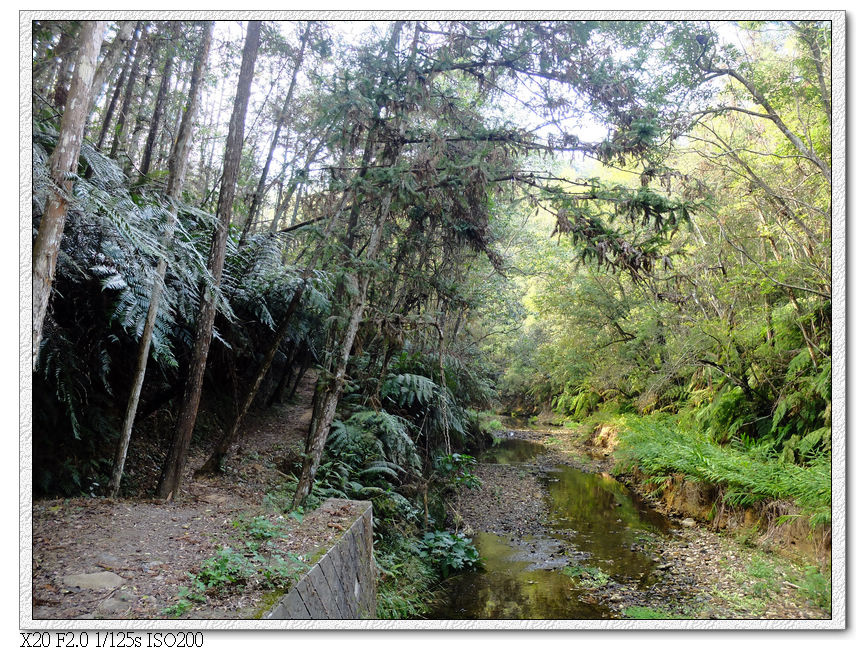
[33,20,108,370]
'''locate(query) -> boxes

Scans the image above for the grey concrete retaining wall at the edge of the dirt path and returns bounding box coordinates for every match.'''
[262,499,376,619]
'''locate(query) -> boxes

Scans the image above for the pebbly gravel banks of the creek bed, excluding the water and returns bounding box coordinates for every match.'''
[460,429,829,619]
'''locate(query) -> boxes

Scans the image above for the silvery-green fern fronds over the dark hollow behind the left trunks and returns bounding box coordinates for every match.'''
[33,124,330,495]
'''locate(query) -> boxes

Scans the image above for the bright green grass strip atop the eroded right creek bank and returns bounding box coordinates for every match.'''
[616,415,832,527]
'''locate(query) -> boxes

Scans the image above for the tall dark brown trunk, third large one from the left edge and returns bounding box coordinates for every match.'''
[157,21,261,499]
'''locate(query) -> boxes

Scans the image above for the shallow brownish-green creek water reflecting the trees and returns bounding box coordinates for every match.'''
[431,438,667,619]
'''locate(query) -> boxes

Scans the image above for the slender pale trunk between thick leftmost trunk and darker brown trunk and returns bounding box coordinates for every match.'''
[108,21,213,497]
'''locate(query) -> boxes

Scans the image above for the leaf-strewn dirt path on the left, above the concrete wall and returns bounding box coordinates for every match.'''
[33,377,348,619]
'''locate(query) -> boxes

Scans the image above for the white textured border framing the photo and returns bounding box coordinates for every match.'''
[18,10,848,631]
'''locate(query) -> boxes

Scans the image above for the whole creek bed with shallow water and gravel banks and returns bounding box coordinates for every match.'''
[433,429,829,619]
